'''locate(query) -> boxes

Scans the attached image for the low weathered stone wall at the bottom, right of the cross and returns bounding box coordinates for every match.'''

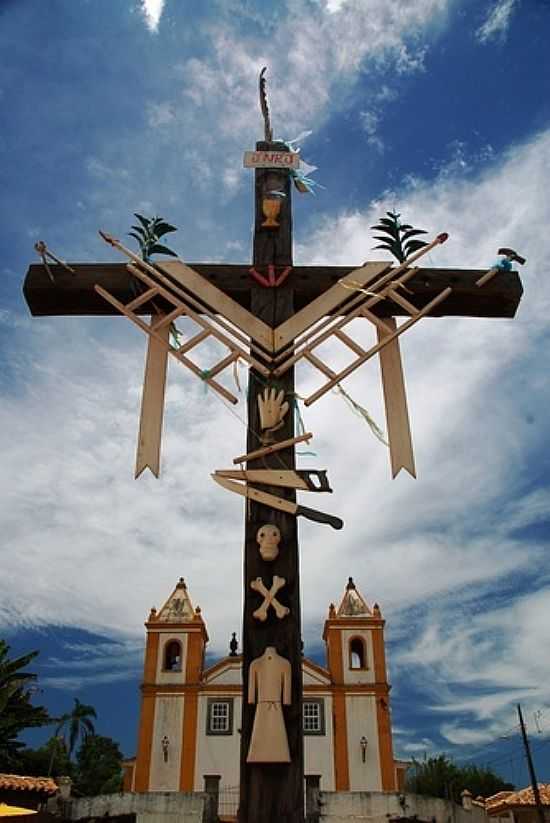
[319,792,488,823]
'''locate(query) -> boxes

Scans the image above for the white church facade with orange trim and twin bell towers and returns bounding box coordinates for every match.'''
[124,578,403,792]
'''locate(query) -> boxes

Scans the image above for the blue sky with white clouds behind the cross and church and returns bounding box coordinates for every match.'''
[0,0,550,785]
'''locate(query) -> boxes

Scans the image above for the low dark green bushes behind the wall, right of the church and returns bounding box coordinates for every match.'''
[407,754,514,803]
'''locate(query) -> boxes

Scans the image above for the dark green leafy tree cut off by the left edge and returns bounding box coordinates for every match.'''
[0,640,52,771]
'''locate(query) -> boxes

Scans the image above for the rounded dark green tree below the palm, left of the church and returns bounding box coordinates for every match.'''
[75,734,122,797]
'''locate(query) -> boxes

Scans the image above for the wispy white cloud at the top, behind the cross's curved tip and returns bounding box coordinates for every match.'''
[175,0,449,138]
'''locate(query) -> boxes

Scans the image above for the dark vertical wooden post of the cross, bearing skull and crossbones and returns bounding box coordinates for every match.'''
[239,142,304,823]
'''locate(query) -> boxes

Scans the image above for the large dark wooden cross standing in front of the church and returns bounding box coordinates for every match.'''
[24,111,522,823]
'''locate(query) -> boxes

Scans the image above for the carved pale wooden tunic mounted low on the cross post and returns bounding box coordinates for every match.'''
[246,646,291,763]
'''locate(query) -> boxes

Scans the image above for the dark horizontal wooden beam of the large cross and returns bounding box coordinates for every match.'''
[23,263,523,317]
